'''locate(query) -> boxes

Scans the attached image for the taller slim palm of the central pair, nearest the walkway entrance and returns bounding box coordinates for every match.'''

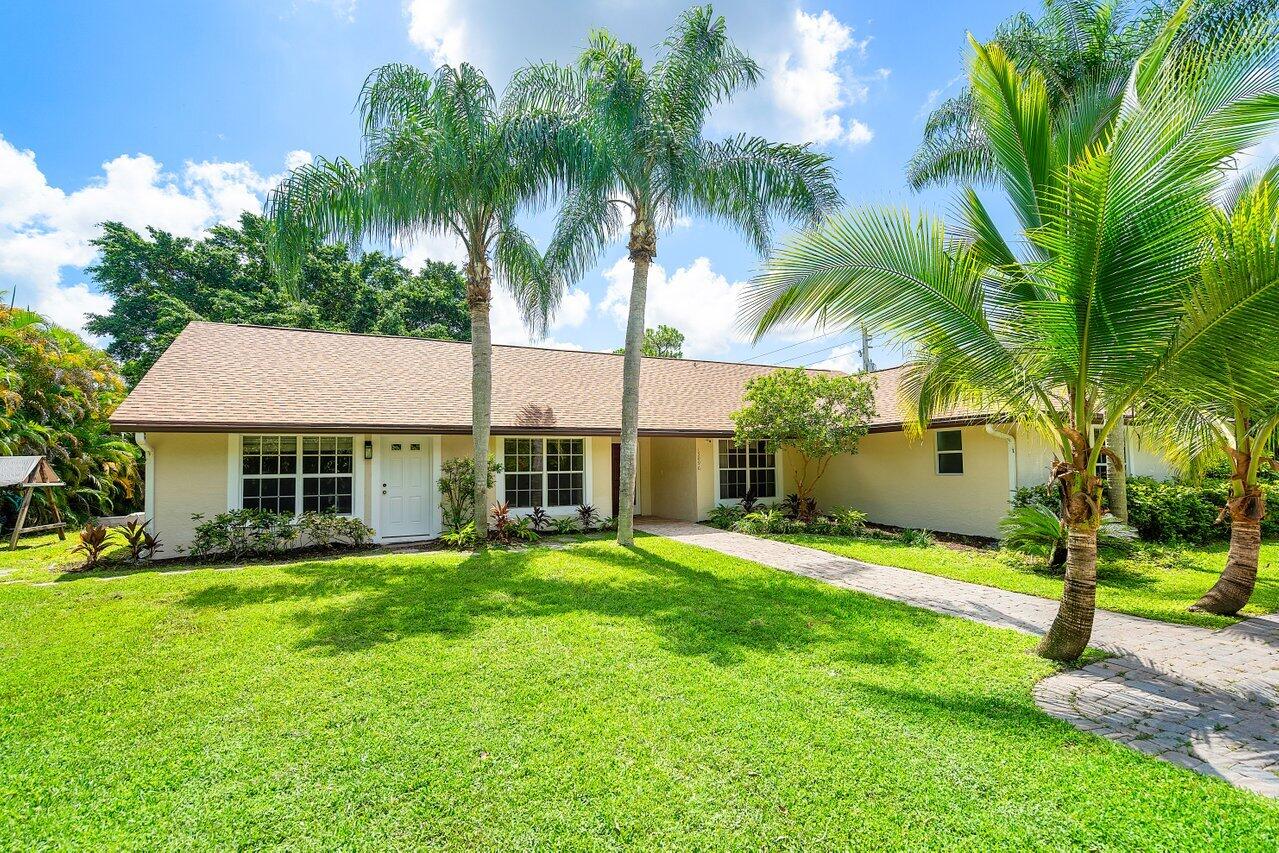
[508,6,839,545]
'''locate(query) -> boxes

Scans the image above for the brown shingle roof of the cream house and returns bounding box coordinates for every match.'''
[111,322,987,435]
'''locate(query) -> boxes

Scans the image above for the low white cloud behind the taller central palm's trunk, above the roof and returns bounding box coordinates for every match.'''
[599,257,746,357]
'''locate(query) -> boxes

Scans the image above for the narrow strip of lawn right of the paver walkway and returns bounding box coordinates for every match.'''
[775,533,1279,628]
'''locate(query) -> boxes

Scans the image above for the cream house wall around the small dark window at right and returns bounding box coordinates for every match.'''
[813,427,1008,536]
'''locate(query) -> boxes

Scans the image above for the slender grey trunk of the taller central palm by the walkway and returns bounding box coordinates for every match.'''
[618,216,656,545]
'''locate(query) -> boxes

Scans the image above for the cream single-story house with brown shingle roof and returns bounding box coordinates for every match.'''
[111,322,1168,555]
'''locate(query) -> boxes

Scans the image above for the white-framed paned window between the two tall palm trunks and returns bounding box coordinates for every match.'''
[501,439,586,509]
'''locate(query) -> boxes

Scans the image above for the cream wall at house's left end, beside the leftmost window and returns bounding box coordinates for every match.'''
[147,432,228,558]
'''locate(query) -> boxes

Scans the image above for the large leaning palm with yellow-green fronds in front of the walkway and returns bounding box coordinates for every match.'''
[744,3,1279,660]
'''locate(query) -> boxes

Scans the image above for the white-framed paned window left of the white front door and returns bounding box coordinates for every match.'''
[240,435,354,515]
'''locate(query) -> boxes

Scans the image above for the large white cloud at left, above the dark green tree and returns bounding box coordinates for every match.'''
[0,137,311,331]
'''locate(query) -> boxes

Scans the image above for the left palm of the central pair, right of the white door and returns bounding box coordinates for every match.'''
[267,64,563,533]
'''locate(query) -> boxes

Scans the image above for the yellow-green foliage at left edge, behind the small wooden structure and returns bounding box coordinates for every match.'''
[0,299,142,527]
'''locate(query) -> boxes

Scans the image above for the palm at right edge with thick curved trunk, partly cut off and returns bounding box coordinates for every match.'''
[1143,161,1279,615]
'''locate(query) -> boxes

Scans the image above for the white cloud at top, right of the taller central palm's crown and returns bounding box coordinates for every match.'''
[770,9,890,145]
